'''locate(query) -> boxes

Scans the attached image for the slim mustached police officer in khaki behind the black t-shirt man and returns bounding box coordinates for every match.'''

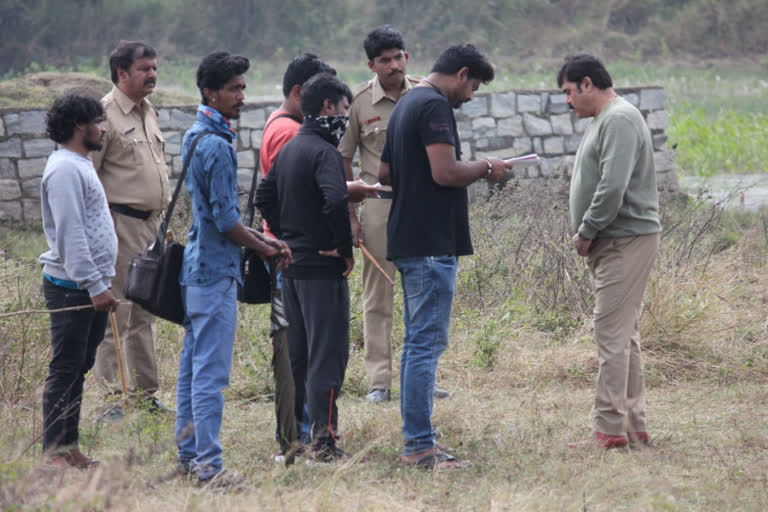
[339,25,436,402]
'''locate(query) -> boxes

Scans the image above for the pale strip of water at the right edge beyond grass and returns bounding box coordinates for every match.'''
[680,174,768,211]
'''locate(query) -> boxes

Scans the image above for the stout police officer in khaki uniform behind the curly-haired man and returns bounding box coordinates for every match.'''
[91,41,170,420]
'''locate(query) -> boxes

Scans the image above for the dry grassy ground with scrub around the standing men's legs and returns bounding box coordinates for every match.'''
[0,185,768,511]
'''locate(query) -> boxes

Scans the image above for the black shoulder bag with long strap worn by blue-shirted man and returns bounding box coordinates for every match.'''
[123,131,216,324]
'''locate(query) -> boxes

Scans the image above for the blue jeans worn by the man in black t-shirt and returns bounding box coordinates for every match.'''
[394,256,457,455]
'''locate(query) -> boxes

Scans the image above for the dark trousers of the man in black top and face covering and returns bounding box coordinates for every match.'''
[283,276,349,448]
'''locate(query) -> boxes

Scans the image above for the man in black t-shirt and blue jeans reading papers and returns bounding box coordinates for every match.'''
[379,44,506,467]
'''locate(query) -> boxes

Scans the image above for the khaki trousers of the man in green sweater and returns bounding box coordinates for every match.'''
[587,233,660,436]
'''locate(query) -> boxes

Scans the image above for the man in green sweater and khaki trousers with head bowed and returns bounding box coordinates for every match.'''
[557,55,661,448]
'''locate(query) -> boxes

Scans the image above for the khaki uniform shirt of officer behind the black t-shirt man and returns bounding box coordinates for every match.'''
[339,76,419,190]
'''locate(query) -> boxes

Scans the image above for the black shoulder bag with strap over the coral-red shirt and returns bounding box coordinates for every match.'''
[237,113,301,304]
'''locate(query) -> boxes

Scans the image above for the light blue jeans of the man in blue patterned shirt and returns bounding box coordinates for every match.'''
[176,277,237,480]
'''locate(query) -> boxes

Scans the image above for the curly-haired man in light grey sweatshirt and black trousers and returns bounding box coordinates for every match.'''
[40,95,118,468]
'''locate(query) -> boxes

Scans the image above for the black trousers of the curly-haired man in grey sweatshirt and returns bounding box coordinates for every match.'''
[43,279,107,452]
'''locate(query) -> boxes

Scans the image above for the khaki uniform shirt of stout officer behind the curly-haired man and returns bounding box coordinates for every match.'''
[91,86,170,211]
